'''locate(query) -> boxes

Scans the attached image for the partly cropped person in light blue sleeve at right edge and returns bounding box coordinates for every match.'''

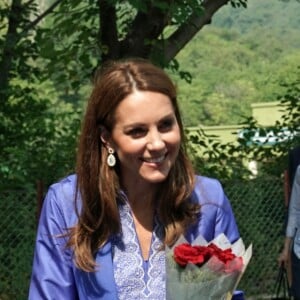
[278,165,300,300]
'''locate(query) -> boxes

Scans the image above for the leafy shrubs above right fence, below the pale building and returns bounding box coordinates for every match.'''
[187,67,300,180]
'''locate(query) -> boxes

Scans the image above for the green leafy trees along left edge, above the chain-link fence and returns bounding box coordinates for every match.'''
[0,0,83,188]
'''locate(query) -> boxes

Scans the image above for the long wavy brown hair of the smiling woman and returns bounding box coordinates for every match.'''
[67,59,199,272]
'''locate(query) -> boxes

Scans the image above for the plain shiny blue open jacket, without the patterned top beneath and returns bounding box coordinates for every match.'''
[28,175,239,300]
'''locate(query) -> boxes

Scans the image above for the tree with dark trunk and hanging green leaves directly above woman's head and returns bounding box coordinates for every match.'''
[34,0,250,89]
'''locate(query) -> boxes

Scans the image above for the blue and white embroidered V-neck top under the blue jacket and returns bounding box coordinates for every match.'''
[112,202,165,300]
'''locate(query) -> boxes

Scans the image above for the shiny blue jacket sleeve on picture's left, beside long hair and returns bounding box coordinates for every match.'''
[28,188,78,300]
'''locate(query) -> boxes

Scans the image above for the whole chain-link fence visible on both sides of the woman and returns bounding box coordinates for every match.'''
[0,179,285,300]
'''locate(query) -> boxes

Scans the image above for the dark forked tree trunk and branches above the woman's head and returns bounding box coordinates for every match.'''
[99,0,230,66]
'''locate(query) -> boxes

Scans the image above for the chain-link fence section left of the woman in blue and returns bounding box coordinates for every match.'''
[0,191,37,300]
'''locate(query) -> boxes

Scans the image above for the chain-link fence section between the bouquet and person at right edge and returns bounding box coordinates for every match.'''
[224,179,286,300]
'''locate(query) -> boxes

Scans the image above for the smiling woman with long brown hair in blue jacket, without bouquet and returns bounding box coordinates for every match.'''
[29,59,239,300]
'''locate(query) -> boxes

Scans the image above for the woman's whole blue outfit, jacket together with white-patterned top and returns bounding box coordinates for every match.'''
[28,175,239,300]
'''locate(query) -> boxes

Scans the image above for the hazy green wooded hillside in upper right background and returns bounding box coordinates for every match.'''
[177,0,300,125]
